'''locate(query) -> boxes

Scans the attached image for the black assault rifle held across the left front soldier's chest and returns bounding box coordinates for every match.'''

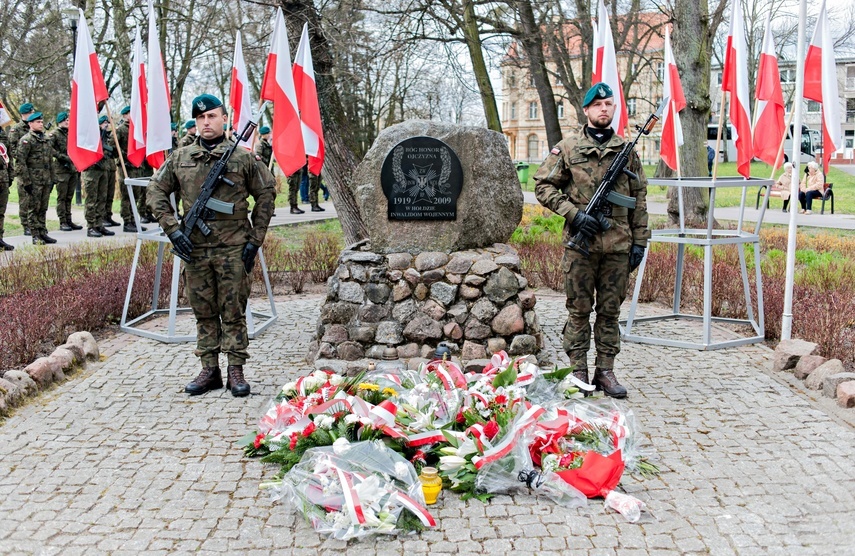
[171,101,267,263]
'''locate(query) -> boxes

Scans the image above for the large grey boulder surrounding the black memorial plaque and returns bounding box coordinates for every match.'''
[351,120,523,254]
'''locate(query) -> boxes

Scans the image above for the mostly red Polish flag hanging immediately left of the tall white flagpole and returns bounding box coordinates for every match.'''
[754,13,785,168]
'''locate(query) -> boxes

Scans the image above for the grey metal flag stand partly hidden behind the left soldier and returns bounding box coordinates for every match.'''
[119,178,278,343]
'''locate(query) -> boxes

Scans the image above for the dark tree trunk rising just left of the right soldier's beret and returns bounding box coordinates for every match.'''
[516,0,561,145]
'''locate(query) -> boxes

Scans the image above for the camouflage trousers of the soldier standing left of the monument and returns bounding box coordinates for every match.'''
[184,245,251,367]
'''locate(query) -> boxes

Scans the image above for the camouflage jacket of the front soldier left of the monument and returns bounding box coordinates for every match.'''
[147,141,276,247]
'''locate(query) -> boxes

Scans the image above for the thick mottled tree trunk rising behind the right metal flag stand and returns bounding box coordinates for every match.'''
[668,0,714,227]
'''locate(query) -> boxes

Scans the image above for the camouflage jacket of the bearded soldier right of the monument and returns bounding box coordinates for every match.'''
[534,130,650,253]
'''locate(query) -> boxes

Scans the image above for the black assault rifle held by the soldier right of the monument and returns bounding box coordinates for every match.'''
[567,97,670,257]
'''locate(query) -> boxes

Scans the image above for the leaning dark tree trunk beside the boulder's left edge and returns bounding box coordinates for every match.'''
[280,0,368,244]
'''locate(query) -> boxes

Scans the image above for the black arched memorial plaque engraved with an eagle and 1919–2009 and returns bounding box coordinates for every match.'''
[380,137,463,220]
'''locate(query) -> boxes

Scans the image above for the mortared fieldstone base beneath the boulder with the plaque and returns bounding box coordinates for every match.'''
[308,241,543,370]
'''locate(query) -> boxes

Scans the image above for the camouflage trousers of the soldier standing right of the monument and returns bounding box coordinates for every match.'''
[561,249,629,369]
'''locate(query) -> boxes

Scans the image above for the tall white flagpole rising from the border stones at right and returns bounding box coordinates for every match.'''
[781,0,807,340]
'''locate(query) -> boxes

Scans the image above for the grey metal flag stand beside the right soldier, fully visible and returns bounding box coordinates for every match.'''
[620,177,773,350]
